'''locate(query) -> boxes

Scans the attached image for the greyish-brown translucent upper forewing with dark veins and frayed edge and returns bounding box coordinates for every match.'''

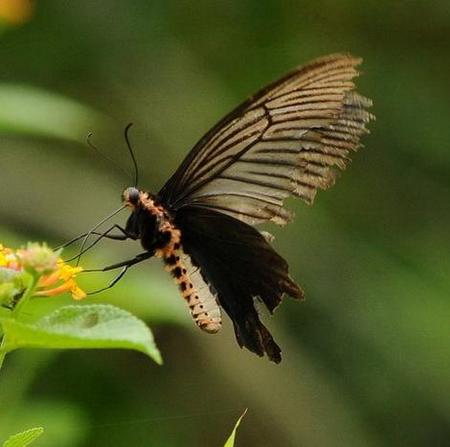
[159,55,373,224]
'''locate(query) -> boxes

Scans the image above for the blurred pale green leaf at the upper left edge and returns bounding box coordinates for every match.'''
[0,84,107,142]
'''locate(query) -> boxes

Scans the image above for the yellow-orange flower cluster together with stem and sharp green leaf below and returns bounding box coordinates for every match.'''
[0,243,162,366]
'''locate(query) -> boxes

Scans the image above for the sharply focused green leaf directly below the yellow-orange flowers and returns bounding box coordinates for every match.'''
[0,304,162,364]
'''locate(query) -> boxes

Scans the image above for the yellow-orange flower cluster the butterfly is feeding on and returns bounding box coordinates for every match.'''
[0,243,86,300]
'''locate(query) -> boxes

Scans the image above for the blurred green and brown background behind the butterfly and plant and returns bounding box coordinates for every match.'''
[0,0,450,447]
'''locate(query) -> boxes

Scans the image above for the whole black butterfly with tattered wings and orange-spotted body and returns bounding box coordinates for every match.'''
[80,55,373,363]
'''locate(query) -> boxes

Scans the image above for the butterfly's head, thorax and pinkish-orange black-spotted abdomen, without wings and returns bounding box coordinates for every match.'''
[123,188,222,333]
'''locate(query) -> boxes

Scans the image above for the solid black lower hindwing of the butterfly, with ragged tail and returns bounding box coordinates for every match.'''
[175,207,303,362]
